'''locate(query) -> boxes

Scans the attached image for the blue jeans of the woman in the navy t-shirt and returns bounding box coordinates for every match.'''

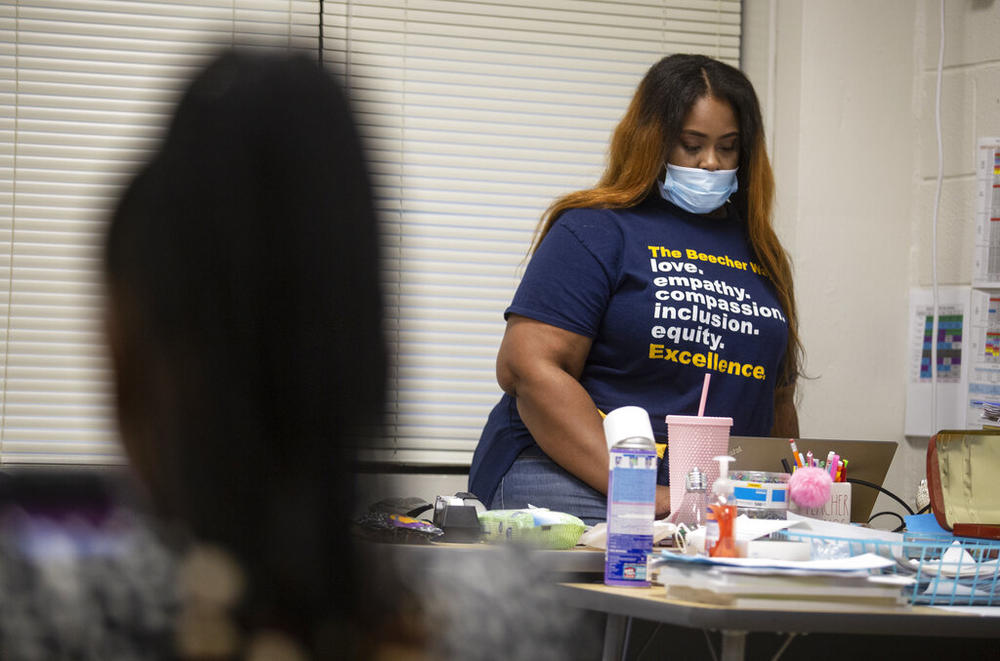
[489,445,608,526]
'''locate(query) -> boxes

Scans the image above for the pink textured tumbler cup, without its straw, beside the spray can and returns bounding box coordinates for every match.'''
[667,415,733,522]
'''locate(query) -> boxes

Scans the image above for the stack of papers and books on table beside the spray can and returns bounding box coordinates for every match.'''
[653,553,914,610]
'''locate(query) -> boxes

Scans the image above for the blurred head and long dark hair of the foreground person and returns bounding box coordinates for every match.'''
[105,52,386,659]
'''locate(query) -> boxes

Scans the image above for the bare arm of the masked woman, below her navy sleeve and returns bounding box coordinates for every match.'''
[497,314,670,515]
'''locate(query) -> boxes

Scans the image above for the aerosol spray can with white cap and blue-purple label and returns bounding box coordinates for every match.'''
[604,406,656,587]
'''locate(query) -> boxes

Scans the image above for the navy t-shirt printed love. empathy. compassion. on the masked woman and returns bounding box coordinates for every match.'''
[469,193,788,503]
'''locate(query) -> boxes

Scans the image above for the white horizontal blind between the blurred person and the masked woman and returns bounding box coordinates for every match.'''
[324,0,740,464]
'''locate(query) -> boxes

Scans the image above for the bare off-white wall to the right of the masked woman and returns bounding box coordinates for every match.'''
[744,0,1000,525]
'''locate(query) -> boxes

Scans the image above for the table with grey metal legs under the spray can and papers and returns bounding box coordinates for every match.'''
[557,583,1000,660]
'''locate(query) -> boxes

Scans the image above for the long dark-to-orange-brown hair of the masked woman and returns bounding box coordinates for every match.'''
[532,55,802,387]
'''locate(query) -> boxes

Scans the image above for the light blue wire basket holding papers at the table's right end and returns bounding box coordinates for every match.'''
[782,529,1000,606]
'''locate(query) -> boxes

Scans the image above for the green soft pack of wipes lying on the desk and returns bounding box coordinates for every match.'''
[479,508,586,549]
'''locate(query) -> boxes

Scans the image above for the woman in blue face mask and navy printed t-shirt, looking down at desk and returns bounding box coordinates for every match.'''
[469,55,801,523]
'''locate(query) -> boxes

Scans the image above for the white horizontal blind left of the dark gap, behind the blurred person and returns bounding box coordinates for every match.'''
[0,0,320,463]
